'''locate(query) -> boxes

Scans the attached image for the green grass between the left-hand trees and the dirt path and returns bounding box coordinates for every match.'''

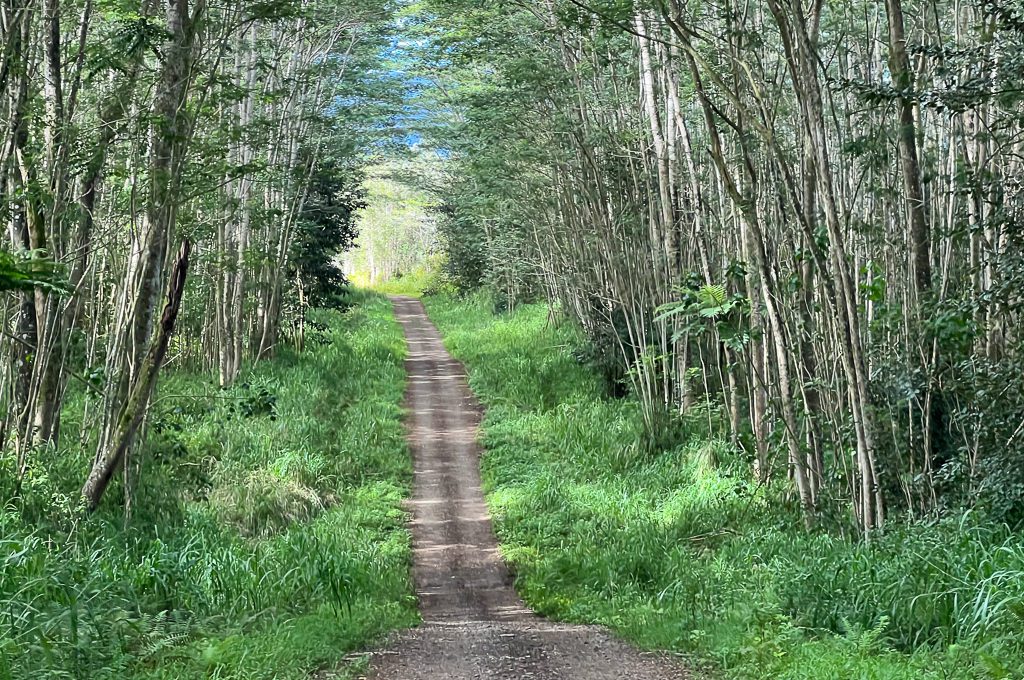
[0,295,417,680]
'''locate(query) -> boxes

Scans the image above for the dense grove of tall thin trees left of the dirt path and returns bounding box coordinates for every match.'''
[0,0,391,506]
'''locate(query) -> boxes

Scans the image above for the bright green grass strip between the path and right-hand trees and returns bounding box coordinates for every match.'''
[426,296,1024,680]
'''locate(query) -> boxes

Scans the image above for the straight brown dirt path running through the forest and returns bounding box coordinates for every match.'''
[370,297,688,680]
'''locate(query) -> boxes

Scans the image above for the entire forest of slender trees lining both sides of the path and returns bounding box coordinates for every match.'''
[0,0,1024,557]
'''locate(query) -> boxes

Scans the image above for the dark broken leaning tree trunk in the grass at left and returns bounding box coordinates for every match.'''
[82,239,191,510]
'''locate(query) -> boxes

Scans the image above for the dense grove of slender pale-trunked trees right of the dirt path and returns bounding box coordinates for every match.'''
[411,0,1024,534]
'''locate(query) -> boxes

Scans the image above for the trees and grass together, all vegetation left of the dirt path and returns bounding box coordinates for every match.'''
[0,0,417,680]
